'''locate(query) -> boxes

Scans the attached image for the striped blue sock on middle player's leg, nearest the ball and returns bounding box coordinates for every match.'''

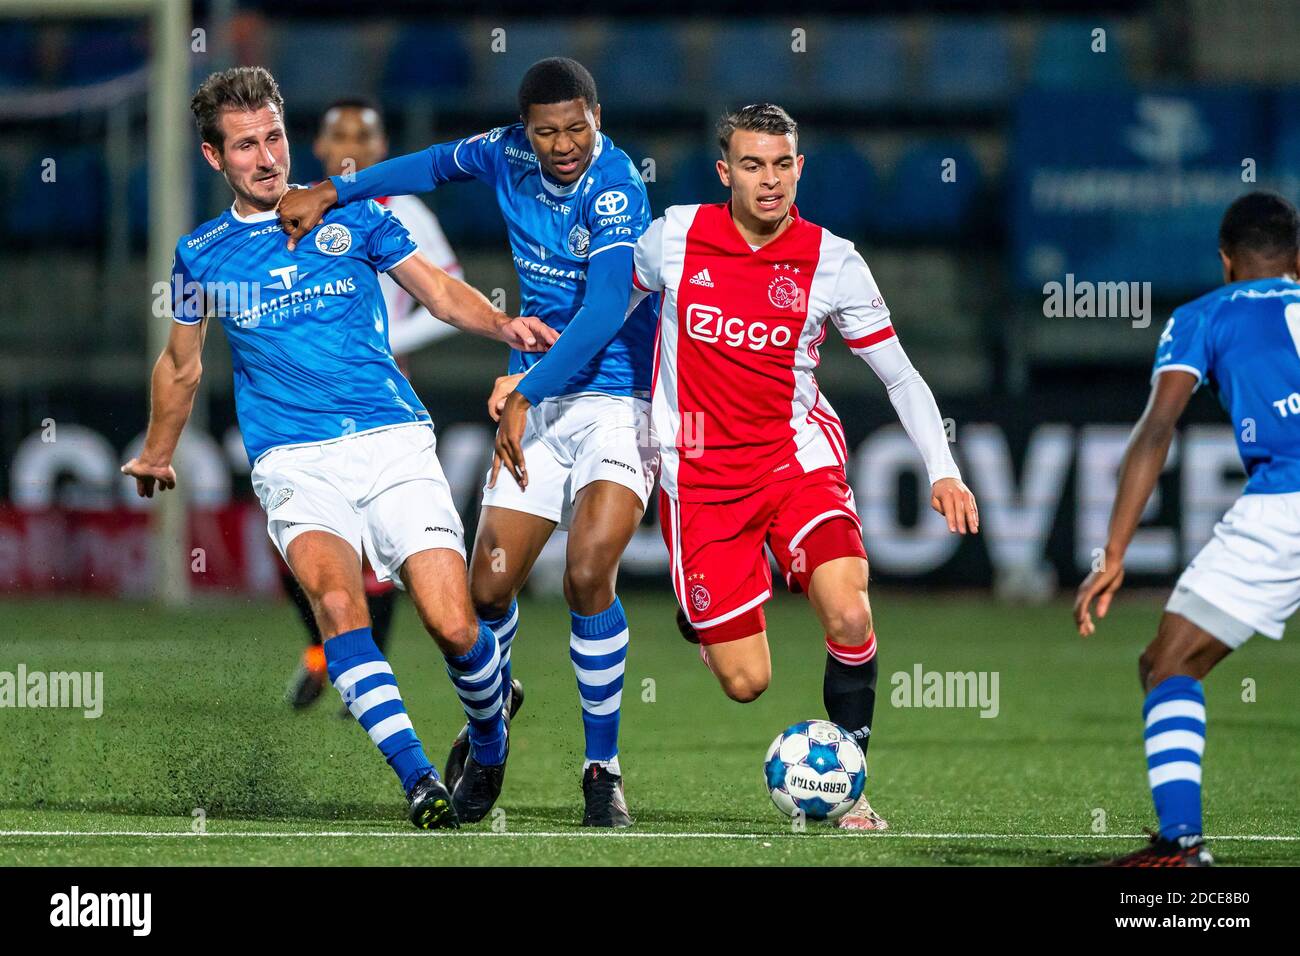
[569,597,628,763]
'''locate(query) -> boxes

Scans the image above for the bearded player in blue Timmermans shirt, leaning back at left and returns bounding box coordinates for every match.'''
[122,66,555,829]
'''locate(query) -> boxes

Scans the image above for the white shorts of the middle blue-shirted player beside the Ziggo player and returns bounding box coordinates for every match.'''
[482,392,659,528]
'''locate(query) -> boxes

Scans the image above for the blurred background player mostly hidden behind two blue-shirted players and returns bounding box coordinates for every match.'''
[280,98,463,717]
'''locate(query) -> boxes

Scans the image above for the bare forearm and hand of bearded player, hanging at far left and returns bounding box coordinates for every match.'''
[122,319,208,498]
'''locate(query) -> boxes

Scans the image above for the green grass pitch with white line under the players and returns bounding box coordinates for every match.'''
[0,591,1300,865]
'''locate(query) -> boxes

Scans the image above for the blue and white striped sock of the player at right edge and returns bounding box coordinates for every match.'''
[1141,676,1205,840]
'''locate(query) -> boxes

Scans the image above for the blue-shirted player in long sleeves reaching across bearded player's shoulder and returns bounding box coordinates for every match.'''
[280,57,659,827]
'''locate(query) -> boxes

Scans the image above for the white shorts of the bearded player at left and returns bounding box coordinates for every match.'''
[252,423,465,588]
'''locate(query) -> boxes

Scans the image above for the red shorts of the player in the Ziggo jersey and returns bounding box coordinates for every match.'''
[659,467,867,644]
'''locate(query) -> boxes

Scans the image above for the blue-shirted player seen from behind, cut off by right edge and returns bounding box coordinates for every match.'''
[1074,191,1300,866]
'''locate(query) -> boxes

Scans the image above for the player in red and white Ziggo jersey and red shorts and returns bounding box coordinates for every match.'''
[497,104,979,830]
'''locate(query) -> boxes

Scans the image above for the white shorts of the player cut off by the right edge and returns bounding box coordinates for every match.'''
[1165,492,1300,648]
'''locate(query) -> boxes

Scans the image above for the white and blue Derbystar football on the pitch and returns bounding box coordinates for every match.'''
[763,721,867,819]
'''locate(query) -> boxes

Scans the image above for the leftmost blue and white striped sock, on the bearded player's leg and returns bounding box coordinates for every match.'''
[325,627,436,793]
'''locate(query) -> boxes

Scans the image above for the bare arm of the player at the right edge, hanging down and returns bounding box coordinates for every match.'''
[1074,369,1197,637]
